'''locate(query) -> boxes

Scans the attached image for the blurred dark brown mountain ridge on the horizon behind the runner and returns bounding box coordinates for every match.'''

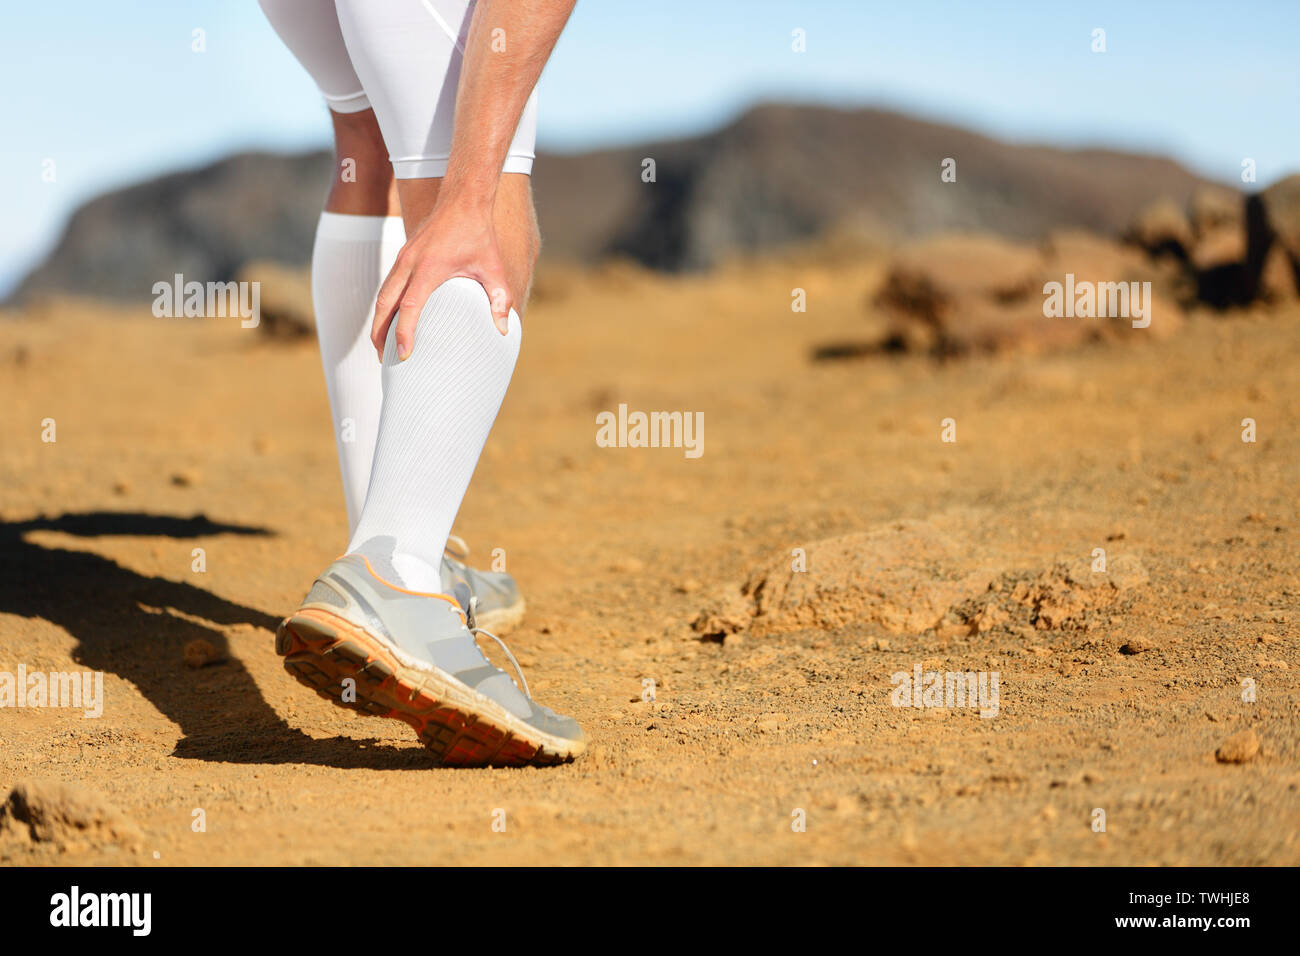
[7,105,1205,299]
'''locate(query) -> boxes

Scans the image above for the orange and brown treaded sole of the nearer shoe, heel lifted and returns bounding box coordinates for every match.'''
[276,607,586,766]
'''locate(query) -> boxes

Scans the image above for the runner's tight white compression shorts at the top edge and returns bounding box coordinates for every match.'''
[259,0,537,179]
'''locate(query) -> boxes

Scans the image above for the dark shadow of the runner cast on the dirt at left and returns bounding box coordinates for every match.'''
[0,511,433,770]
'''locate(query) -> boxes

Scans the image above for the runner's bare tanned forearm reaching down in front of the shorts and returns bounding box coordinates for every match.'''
[439,0,576,211]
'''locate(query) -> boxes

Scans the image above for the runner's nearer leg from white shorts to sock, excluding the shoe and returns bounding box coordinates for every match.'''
[335,0,540,592]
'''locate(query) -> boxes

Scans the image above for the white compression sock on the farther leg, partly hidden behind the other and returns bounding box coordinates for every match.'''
[312,212,406,536]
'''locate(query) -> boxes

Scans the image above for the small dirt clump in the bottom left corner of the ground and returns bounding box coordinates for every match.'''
[0,780,142,849]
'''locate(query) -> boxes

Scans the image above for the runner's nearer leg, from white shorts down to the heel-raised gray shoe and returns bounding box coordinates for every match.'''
[276,0,585,765]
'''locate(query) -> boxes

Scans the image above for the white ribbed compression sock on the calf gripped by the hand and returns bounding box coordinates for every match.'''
[348,278,523,592]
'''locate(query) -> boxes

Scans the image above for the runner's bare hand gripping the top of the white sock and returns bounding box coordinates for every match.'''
[371,203,515,362]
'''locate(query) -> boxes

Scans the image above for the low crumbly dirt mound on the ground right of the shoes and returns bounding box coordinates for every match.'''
[692,515,997,640]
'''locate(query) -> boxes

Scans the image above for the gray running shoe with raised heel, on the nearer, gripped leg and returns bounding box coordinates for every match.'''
[276,554,586,766]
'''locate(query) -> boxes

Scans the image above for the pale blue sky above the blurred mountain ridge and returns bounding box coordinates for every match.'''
[0,0,1300,295]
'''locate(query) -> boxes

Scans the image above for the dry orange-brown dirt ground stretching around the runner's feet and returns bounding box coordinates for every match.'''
[0,256,1300,865]
